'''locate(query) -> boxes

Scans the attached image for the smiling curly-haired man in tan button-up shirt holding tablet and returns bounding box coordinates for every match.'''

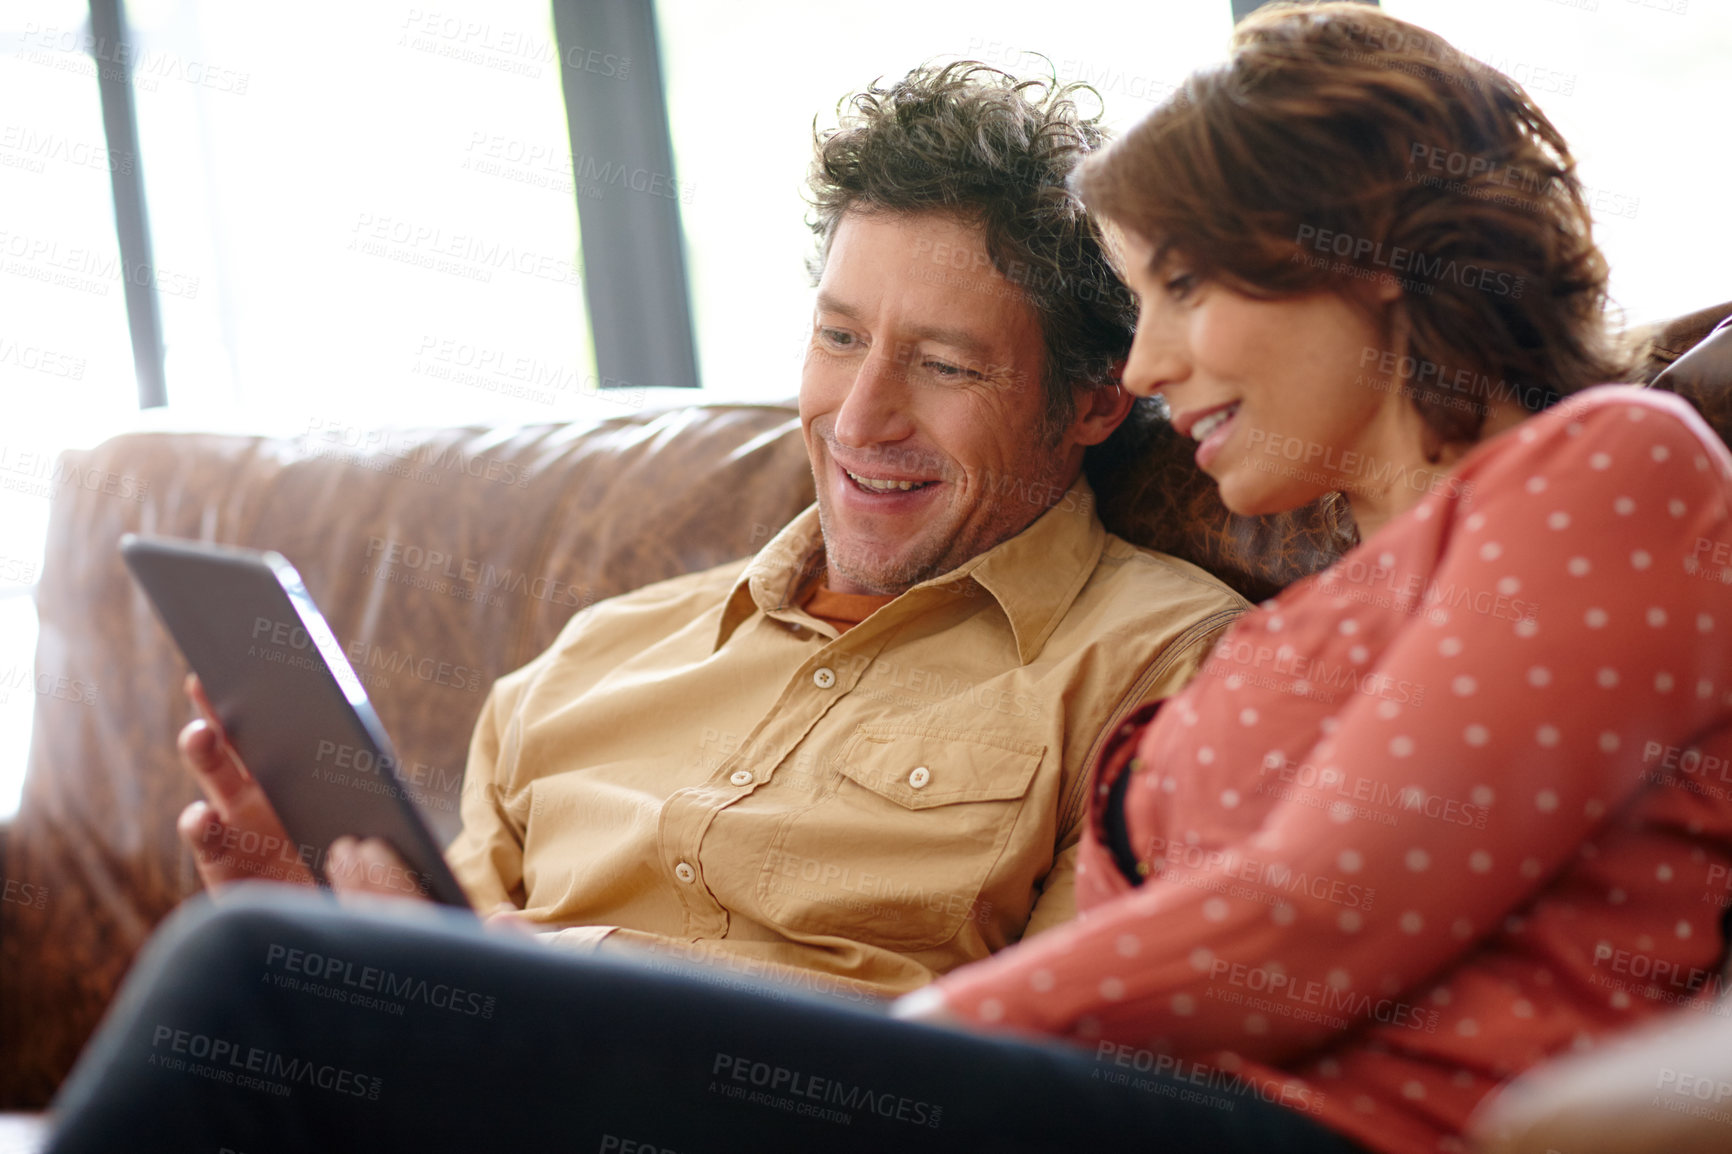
[180,66,1242,995]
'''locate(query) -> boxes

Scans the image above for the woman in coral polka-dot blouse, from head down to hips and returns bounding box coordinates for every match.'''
[902,3,1732,1154]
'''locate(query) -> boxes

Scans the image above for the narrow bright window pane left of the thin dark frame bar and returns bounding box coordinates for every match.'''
[0,0,139,818]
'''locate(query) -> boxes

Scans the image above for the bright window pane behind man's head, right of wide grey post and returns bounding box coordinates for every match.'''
[656,0,1233,400]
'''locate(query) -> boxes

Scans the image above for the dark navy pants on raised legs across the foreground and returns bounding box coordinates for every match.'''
[50,891,1358,1154]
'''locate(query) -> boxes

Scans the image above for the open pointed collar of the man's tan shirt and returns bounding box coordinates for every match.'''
[715,473,1107,665]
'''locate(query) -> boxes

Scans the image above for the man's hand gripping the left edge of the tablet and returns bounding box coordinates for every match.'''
[175,674,313,892]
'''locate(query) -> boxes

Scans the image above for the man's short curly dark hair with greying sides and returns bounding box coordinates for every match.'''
[807,61,1136,433]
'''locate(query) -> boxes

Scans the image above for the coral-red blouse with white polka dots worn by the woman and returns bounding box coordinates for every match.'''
[939,386,1732,1154]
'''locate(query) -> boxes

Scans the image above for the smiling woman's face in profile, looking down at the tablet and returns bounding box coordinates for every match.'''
[1121,228,1434,523]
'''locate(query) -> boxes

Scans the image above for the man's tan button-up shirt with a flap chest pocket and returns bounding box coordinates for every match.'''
[447,480,1245,995]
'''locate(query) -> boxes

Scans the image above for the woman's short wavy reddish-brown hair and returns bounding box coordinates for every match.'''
[1074,2,1625,442]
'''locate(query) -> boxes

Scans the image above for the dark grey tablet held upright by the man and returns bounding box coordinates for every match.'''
[120,534,469,908]
